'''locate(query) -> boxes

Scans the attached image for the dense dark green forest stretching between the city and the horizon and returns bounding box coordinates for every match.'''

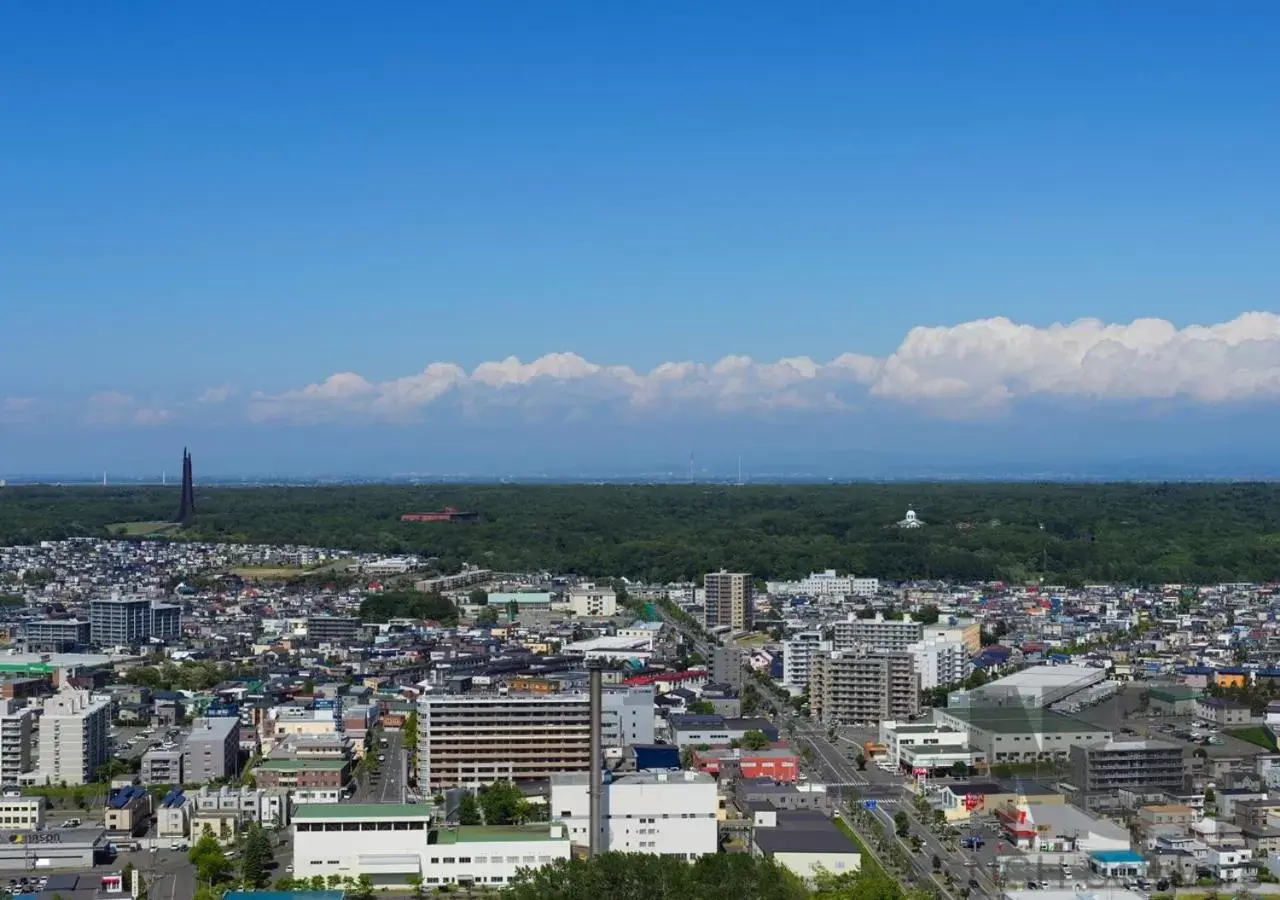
[0,484,1280,583]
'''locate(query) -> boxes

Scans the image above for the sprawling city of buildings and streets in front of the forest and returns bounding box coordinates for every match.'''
[0,489,1280,900]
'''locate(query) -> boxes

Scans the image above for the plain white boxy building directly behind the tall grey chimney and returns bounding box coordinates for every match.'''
[550,771,719,859]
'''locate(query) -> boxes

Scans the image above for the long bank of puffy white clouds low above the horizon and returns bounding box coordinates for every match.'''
[247,312,1280,422]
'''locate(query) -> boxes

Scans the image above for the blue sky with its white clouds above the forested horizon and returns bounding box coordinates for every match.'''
[0,0,1280,476]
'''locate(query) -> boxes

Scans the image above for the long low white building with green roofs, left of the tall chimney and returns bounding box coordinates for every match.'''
[293,803,571,890]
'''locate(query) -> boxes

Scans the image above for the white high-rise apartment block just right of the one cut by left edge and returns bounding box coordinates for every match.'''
[38,690,111,785]
